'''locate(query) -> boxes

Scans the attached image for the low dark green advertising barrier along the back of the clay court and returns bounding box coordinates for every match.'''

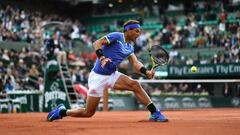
[0,90,240,113]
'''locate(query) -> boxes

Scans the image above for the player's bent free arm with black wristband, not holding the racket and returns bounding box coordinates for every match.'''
[93,36,111,67]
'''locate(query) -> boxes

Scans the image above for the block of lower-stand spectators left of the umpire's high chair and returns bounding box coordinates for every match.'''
[0,47,45,93]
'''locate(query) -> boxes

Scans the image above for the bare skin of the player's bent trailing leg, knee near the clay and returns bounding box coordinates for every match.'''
[67,96,100,117]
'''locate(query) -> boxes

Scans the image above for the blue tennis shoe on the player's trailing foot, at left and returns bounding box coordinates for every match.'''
[47,104,66,121]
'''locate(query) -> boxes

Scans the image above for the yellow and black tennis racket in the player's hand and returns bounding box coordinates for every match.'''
[148,44,169,69]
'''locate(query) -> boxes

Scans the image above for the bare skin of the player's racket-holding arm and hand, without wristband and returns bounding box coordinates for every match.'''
[128,53,155,79]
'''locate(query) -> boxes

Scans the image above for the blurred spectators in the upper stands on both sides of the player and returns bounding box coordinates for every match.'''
[0,3,240,64]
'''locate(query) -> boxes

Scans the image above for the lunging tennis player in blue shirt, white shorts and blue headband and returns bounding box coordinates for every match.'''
[47,20,168,122]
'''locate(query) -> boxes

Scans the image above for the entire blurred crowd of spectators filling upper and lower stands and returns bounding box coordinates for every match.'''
[0,1,240,97]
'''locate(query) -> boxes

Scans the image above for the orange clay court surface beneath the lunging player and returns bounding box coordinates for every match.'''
[0,108,240,135]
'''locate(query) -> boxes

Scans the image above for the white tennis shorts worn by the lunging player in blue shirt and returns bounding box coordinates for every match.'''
[88,71,122,97]
